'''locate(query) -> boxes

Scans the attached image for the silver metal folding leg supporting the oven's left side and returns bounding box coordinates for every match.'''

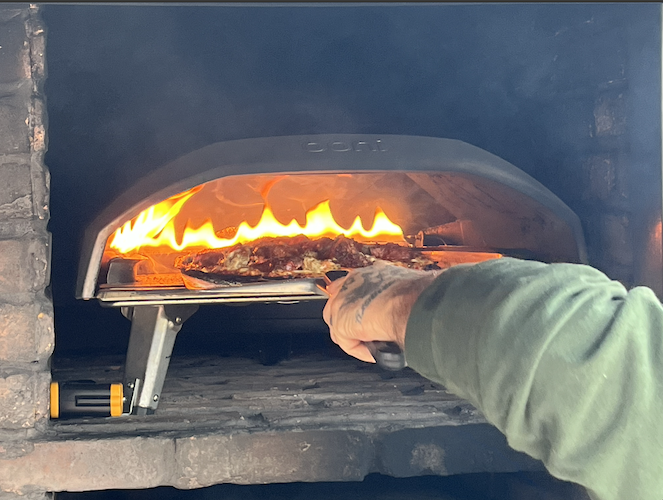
[122,305,198,415]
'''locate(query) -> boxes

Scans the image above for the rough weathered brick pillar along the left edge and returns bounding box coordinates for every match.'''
[0,4,54,500]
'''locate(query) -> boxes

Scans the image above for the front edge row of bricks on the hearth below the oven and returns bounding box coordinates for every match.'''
[0,424,543,493]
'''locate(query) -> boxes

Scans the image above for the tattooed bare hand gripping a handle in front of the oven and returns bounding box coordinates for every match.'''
[323,262,441,363]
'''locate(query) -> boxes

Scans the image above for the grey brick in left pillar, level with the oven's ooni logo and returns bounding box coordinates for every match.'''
[0,80,32,154]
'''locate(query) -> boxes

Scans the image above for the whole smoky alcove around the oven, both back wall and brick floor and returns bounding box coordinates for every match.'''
[32,4,663,496]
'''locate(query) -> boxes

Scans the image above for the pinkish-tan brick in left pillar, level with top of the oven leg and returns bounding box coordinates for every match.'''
[0,297,55,363]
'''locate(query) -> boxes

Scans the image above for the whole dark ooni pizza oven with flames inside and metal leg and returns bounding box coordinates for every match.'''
[77,135,587,414]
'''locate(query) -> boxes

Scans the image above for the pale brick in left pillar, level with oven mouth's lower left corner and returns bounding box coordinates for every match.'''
[0,236,51,294]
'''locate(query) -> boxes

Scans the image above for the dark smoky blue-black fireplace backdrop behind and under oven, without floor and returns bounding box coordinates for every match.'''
[35,4,663,498]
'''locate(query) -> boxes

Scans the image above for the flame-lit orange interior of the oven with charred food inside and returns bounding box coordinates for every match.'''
[101,172,507,291]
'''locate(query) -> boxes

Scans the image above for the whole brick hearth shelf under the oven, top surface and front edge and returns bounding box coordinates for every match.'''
[6,355,543,492]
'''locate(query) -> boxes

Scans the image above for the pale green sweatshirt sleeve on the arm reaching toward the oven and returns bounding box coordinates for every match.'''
[405,258,663,500]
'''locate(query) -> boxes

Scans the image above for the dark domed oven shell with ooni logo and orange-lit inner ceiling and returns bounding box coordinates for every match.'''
[76,135,586,299]
